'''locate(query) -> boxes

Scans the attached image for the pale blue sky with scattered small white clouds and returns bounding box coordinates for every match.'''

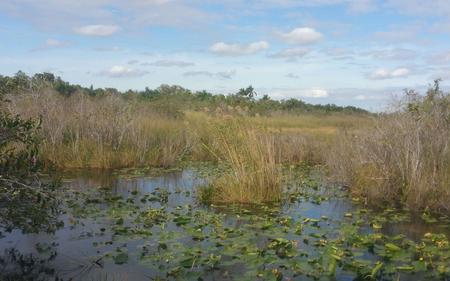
[0,0,450,111]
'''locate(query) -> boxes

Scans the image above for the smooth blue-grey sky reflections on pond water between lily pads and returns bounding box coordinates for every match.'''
[0,170,448,280]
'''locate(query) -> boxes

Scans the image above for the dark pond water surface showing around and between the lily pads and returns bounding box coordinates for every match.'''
[0,169,449,280]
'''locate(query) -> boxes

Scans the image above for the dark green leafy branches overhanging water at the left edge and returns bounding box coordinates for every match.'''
[0,88,59,232]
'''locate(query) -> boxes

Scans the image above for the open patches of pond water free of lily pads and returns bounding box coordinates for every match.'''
[0,169,448,280]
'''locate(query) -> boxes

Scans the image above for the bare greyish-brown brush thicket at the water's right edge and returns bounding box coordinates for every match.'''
[328,82,450,213]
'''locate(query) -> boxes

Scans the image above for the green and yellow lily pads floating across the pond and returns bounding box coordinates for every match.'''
[60,165,450,280]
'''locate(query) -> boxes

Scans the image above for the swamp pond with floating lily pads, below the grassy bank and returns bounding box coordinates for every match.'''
[0,168,450,280]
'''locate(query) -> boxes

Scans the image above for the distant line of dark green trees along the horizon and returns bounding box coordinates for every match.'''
[0,71,368,115]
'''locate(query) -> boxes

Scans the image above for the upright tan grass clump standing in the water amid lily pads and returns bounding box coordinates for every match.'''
[204,119,282,203]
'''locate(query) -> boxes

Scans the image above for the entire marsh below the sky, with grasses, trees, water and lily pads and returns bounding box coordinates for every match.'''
[0,73,450,280]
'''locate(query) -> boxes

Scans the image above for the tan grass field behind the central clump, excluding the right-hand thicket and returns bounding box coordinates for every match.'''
[6,88,348,168]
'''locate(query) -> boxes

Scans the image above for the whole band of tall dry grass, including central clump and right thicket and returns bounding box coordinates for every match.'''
[4,82,450,213]
